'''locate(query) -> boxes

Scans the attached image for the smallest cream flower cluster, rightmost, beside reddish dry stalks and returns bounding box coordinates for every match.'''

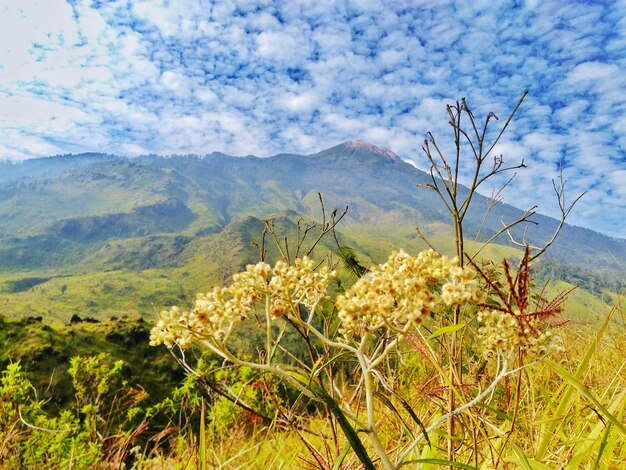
[478,310,561,358]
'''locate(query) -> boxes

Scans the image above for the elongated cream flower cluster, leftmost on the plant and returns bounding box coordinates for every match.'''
[150,257,335,349]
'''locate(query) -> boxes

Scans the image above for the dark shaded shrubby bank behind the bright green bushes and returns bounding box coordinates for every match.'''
[0,317,184,410]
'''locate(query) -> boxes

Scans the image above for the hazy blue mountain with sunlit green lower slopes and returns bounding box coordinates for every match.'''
[0,141,626,319]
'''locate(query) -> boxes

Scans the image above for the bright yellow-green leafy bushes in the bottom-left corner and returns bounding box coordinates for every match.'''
[0,353,197,469]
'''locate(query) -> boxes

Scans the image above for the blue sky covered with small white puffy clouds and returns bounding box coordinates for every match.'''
[0,0,626,238]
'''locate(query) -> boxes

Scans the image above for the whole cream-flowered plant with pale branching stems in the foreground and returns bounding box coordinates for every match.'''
[150,249,550,468]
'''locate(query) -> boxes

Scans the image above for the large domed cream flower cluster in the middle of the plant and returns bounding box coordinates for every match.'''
[337,250,481,335]
